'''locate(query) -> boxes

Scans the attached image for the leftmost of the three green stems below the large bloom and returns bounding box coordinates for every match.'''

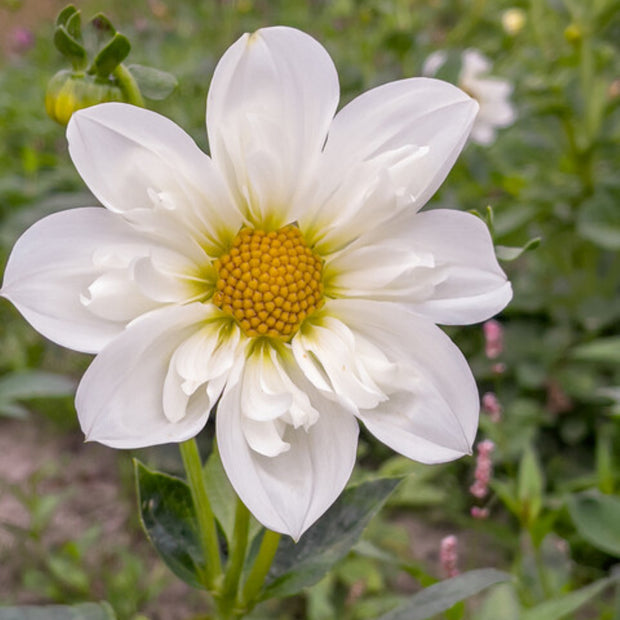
[179,439,222,590]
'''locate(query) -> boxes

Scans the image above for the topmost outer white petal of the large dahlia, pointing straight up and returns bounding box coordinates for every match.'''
[207,27,339,225]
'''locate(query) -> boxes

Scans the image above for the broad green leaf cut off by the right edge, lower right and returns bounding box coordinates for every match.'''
[568,492,620,557]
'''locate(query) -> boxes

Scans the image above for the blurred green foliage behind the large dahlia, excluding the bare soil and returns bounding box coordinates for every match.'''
[0,0,620,620]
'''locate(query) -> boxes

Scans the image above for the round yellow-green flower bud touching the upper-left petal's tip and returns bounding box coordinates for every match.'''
[45,69,127,125]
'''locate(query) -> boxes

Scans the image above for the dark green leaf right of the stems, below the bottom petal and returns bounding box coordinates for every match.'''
[261,478,401,600]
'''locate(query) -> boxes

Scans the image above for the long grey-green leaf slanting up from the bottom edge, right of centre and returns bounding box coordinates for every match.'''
[372,568,510,620]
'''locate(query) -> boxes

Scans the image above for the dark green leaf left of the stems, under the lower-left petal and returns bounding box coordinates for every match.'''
[134,459,204,588]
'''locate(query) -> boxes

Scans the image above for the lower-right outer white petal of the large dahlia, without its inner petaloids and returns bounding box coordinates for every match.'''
[325,300,479,463]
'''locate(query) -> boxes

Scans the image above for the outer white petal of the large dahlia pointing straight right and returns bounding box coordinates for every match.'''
[327,209,512,325]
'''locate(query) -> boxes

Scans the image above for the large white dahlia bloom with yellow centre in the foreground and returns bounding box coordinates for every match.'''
[1,27,511,538]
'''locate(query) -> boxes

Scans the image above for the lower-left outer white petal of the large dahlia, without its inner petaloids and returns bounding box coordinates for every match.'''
[76,304,218,448]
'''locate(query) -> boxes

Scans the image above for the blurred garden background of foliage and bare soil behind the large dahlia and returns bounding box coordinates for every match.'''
[0,0,620,620]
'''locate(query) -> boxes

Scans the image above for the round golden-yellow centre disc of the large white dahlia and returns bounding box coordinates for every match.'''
[213,225,324,340]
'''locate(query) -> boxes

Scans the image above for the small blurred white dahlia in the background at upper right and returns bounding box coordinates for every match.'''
[422,49,517,145]
